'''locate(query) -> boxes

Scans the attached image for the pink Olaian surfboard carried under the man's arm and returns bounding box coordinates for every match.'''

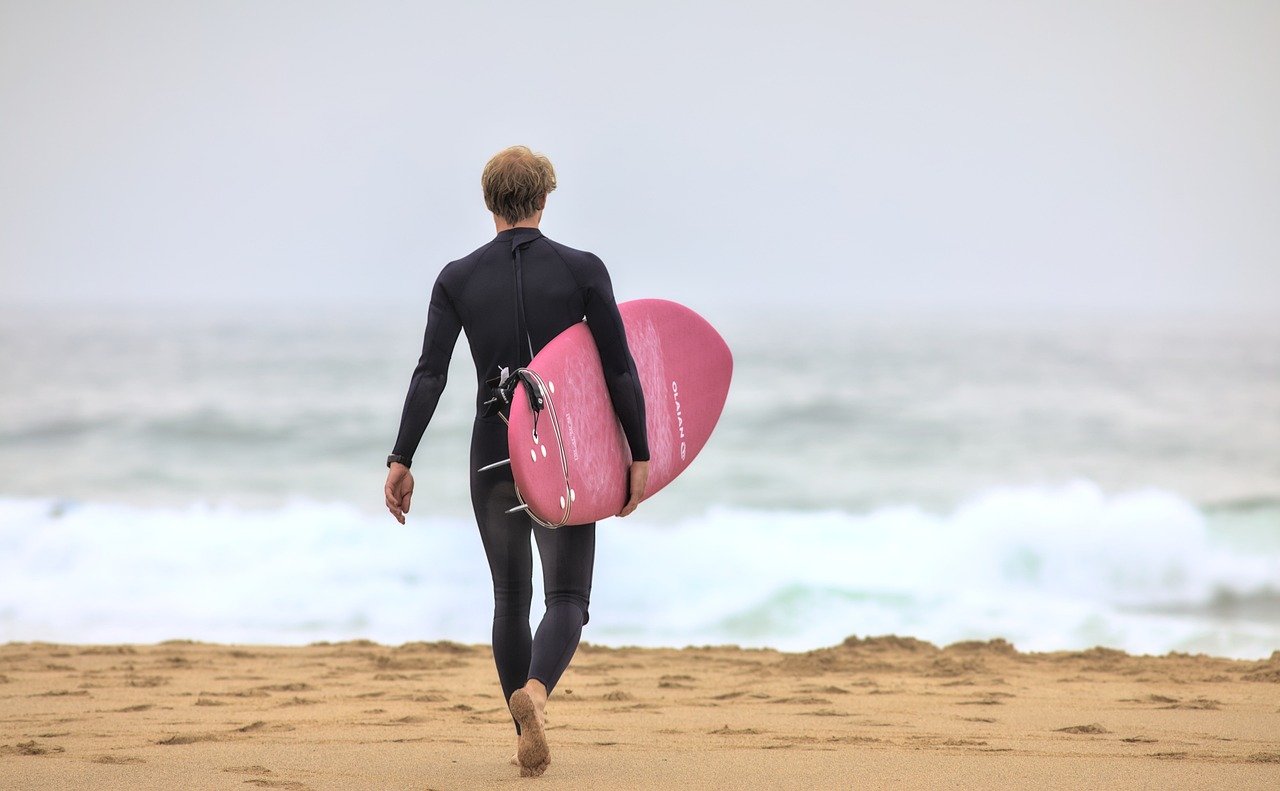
[507,300,733,527]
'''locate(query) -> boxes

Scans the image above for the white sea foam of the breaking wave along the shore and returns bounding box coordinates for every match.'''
[0,483,1280,657]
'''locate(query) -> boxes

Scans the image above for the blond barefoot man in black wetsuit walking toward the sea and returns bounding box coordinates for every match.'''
[384,146,649,777]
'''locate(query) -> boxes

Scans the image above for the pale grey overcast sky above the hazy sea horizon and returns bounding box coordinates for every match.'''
[0,0,1280,312]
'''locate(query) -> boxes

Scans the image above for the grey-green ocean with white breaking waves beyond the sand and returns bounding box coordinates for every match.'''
[0,305,1280,658]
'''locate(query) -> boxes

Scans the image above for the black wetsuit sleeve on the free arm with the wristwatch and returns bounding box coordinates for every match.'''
[392,275,462,459]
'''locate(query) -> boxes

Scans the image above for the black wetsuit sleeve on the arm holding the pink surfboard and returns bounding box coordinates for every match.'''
[584,256,649,461]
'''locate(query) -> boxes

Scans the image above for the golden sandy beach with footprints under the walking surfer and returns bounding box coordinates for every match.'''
[0,637,1280,790]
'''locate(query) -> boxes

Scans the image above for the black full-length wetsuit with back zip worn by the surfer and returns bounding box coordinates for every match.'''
[393,228,649,731]
